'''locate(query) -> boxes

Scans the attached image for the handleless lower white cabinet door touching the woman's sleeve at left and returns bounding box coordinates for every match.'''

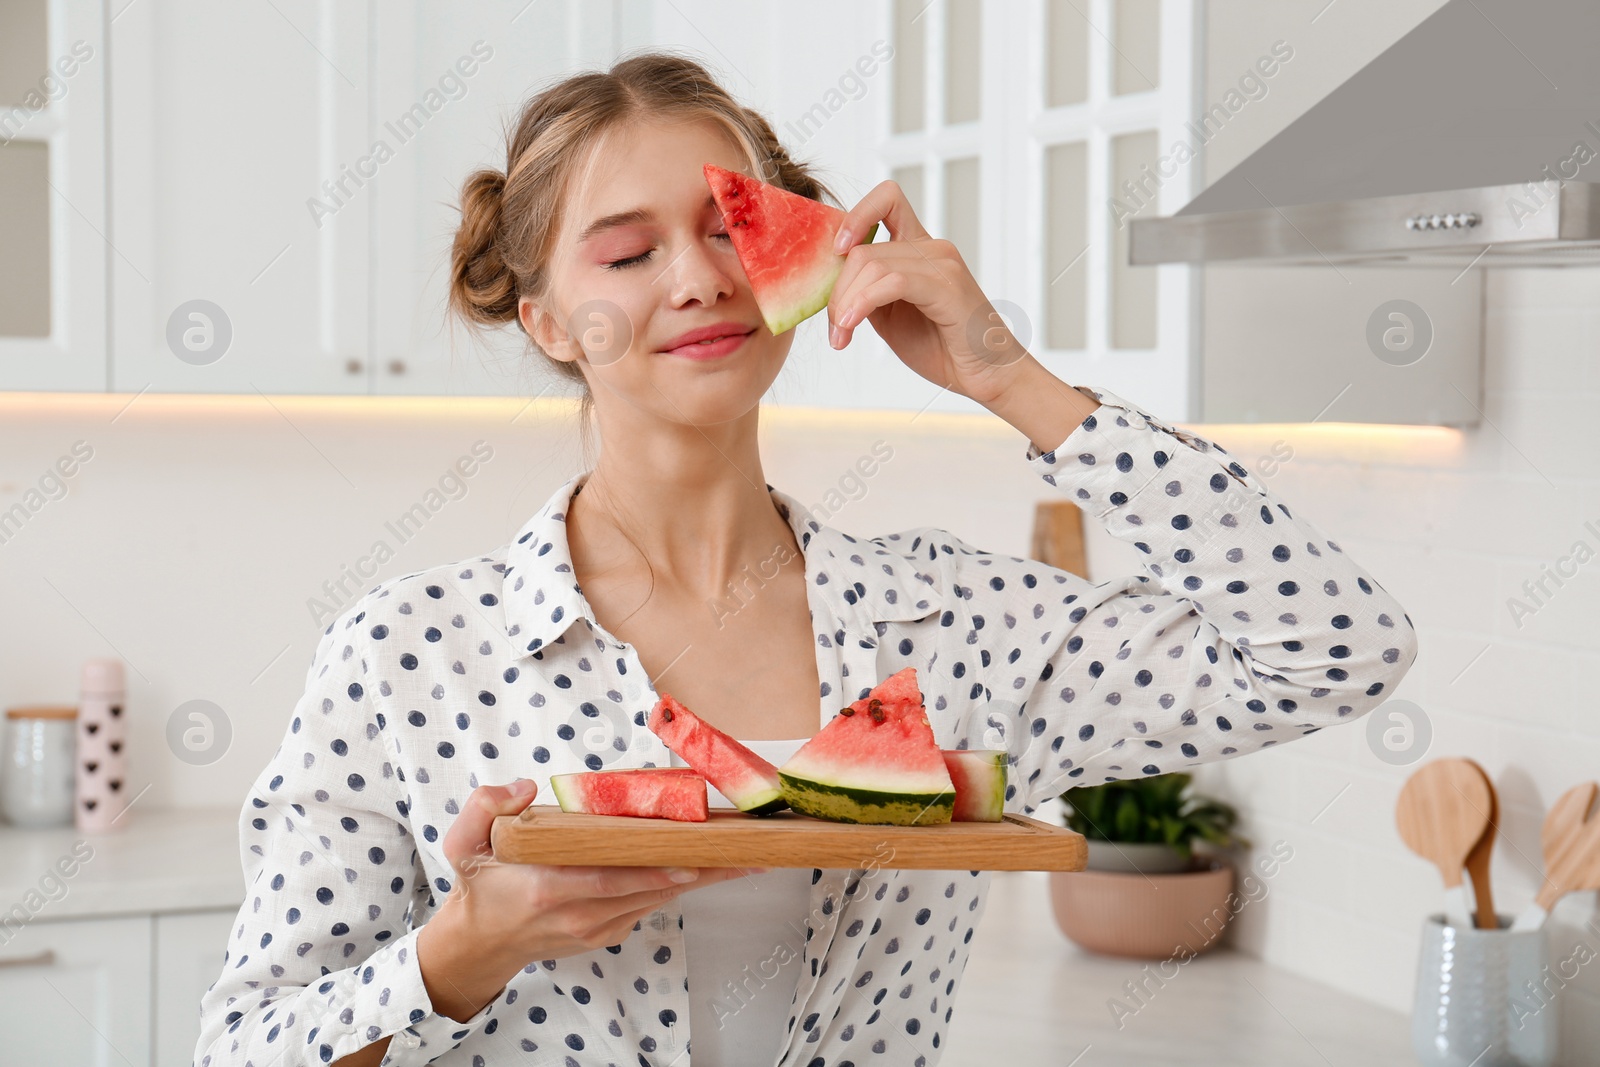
[152,909,238,1065]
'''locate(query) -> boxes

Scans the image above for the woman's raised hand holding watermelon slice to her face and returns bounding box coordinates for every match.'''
[827,181,1032,405]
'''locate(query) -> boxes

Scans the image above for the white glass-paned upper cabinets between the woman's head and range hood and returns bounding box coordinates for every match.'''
[636,0,1197,418]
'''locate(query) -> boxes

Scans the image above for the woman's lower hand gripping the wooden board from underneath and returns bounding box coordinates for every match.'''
[419,779,760,976]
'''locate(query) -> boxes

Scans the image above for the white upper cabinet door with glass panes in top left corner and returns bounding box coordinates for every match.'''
[0,0,114,392]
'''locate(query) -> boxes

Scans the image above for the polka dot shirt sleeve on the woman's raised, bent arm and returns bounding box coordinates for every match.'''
[963,387,1416,811]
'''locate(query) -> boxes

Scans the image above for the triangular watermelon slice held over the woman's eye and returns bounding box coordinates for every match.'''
[701,163,878,335]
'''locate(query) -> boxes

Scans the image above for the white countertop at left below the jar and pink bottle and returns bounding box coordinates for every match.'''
[0,805,245,920]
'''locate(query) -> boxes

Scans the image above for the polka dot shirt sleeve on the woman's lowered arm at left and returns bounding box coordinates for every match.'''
[194,600,494,1067]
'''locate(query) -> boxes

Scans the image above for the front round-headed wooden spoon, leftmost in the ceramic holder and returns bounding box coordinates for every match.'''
[1395,758,1490,926]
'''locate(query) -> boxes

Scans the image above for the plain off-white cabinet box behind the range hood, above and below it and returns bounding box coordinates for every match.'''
[1196,0,1485,426]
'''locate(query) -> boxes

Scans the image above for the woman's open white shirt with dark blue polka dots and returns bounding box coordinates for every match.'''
[195,390,1416,1067]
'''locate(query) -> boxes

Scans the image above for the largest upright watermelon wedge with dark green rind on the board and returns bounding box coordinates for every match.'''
[778,667,955,825]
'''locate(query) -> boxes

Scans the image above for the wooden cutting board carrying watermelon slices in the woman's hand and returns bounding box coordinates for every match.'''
[490,805,1088,870]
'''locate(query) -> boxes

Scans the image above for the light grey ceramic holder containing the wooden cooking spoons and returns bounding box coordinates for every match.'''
[1411,913,1560,1067]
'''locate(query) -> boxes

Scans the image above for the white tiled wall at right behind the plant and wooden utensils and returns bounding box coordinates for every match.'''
[1197,270,1600,1067]
